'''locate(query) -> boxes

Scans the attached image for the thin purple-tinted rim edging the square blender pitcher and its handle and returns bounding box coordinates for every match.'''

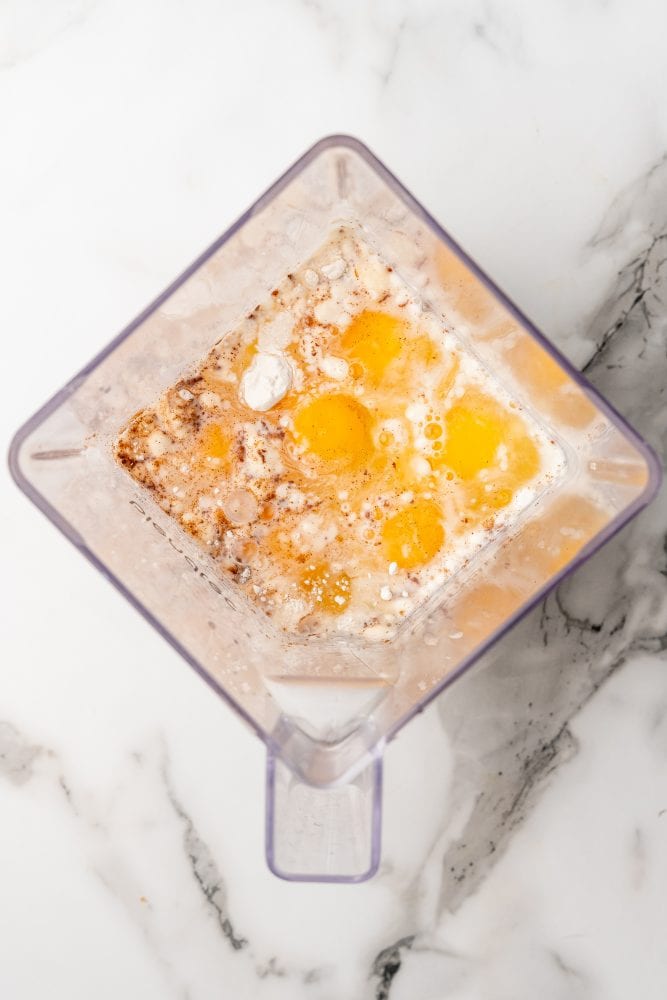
[8,135,662,882]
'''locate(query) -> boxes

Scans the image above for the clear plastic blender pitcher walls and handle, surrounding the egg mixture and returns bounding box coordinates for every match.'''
[10,136,660,882]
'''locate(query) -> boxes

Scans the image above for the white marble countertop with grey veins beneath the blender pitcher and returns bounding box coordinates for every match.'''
[0,0,667,1000]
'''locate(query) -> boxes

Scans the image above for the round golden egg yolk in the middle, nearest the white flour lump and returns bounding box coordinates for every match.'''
[294,393,373,469]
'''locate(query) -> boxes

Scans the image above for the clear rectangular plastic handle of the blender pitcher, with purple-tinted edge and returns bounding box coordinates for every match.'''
[266,749,382,882]
